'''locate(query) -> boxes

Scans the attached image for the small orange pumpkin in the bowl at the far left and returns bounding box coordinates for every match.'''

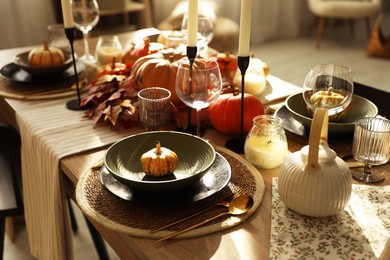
[27,41,64,67]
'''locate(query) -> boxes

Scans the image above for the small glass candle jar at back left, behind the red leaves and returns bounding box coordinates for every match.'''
[95,35,122,65]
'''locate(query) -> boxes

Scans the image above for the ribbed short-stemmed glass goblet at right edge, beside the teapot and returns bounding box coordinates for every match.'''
[352,117,390,183]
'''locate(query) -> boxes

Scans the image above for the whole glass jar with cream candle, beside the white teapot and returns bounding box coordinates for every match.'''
[244,115,288,169]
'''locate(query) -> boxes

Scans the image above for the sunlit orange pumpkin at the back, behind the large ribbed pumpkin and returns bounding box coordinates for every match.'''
[122,37,164,69]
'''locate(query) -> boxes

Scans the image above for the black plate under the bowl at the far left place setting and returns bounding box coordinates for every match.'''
[0,62,85,84]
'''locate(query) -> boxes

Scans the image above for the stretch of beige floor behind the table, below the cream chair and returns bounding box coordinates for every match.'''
[252,22,390,92]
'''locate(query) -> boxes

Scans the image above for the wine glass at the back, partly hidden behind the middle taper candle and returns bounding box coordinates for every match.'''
[181,14,214,52]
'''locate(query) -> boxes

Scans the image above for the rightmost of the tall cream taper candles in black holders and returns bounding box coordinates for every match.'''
[238,0,252,57]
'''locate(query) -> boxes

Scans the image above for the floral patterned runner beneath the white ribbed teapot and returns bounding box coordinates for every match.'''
[270,178,390,259]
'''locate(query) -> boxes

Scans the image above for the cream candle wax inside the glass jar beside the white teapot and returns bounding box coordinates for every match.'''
[244,135,288,169]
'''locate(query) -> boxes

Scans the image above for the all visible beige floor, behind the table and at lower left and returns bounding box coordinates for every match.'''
[4,20,390,260]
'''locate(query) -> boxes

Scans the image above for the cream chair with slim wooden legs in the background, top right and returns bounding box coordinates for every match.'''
[308,0,381,48]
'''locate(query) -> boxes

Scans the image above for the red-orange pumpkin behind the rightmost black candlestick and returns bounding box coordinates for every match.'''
[209,92,264,134]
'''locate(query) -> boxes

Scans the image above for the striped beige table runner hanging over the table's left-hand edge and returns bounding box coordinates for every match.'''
[17,99,141,259]
